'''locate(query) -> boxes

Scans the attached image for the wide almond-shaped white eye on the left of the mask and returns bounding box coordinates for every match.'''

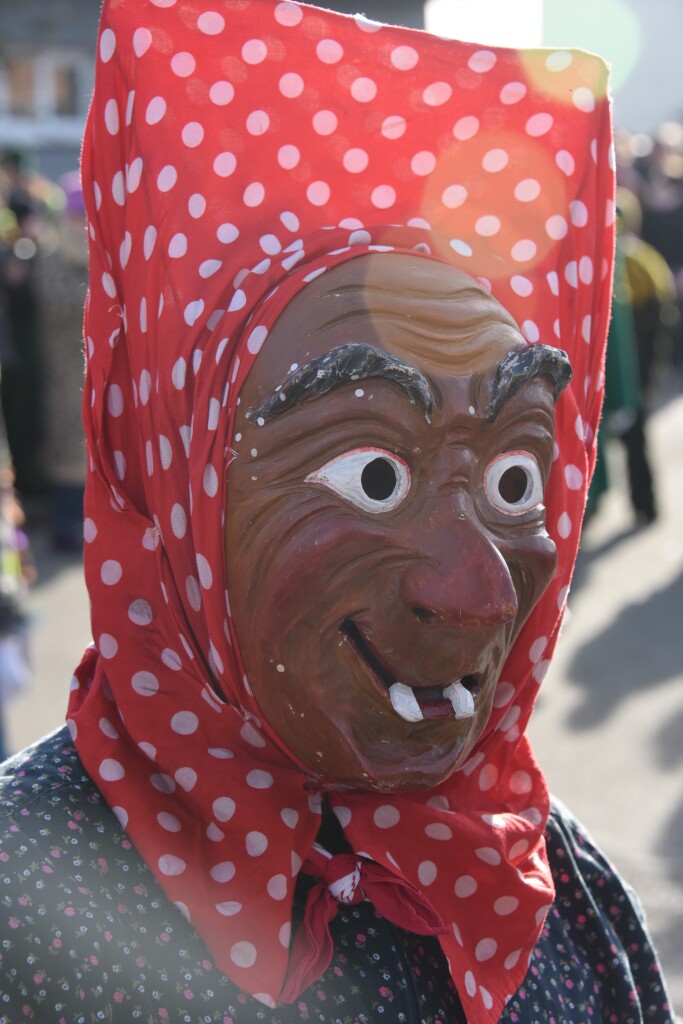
[306,447,411,512]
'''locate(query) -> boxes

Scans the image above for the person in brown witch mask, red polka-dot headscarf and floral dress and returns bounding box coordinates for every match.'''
[0,0,672,1024]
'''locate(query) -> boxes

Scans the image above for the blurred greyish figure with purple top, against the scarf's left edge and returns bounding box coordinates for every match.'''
[36,171,88,552]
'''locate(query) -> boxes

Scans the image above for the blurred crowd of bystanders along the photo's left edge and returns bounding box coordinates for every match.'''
[0,152,87,761]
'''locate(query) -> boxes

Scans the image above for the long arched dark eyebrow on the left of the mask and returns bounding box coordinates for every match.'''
[247,342,434,423]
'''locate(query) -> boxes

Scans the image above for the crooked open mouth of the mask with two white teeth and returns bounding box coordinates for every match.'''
[340,618,481,722]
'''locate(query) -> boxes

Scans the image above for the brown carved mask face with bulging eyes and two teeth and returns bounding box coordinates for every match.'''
[226,254,566,791]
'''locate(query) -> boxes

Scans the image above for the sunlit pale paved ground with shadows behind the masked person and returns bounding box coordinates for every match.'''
[6,392,683,1013]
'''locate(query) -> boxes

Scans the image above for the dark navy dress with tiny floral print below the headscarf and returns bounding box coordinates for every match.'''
[0,729,673,1024]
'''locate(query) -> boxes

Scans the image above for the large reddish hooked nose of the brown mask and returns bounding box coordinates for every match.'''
[400,513,518,629]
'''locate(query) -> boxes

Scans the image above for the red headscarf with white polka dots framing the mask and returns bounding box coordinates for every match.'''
[69,0,613,1024]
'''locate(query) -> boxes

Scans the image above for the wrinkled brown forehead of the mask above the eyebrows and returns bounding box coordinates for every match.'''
[257,253,524,387]
